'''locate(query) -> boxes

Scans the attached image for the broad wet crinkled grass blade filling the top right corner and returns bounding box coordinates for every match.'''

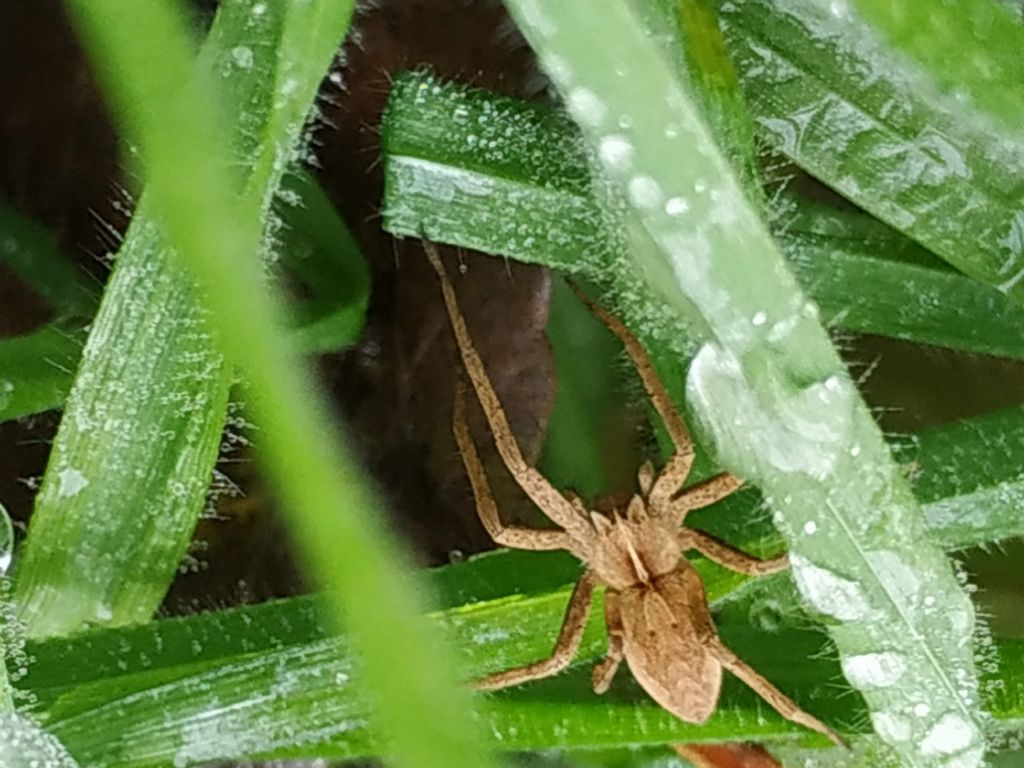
[719,0,1024,303]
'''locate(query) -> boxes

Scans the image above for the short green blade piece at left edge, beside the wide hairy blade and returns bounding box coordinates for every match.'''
[0,325,85,421]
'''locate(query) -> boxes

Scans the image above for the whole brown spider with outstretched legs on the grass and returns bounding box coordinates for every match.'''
[424,243,844,744]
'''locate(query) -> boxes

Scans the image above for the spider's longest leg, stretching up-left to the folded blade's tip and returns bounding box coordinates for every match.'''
[423,241,591,539]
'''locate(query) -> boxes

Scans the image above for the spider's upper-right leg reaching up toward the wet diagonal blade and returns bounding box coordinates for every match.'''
[569,281,693,510]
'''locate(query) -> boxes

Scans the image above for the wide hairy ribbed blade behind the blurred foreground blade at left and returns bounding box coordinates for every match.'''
[16,3,307,636]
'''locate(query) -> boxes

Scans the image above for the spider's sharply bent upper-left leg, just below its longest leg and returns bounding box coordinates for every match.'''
[452,377,570,550]
